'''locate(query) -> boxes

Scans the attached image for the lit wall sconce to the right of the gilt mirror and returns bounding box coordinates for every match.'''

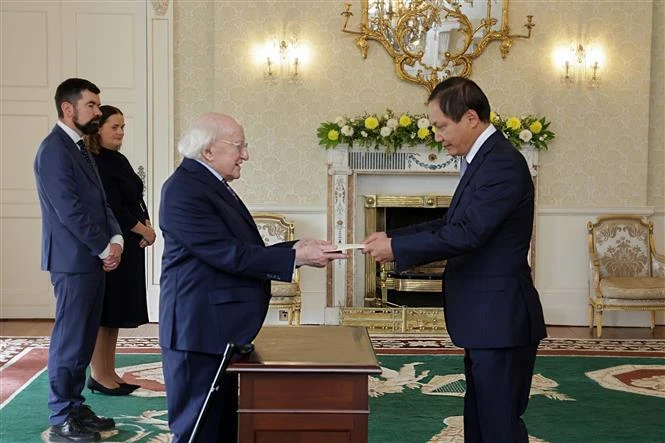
[554,43,605,88]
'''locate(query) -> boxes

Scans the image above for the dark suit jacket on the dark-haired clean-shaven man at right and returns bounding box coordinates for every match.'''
[389,131,546,348]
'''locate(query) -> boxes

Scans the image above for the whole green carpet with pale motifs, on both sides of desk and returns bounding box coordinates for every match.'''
[0,354,665,443]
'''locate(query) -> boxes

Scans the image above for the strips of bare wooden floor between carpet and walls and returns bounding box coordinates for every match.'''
[0,320,665,339]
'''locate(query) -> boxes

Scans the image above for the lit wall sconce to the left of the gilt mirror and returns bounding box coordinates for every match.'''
[256,37,309,85]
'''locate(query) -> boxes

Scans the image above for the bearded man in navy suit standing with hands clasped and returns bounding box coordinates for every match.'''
[34,78,123,442]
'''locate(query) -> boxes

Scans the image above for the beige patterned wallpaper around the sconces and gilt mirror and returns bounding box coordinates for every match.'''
[174,0,665,208]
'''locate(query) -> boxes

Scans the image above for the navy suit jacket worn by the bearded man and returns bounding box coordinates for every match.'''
[34,125,122,273]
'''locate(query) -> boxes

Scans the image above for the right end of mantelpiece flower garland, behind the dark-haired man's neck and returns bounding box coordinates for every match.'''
[490,111,556,150]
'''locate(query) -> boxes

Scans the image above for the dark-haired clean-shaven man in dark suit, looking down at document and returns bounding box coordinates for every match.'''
[363,77,546,443]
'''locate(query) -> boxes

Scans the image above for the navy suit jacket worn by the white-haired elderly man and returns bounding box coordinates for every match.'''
[159,159,295,354]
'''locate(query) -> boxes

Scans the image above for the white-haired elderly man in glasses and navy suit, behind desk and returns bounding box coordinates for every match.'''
[159,113,346,443]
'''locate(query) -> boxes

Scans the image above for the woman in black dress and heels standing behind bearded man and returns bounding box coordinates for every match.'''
[86,105,155,395]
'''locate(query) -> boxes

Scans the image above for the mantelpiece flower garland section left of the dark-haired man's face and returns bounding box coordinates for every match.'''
[317,109,442,152]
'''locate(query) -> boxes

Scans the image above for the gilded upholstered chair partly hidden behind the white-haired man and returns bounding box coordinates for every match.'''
[252,212,301,325]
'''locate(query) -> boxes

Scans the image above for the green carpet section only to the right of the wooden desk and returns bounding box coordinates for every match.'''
[369,355,665,443]
